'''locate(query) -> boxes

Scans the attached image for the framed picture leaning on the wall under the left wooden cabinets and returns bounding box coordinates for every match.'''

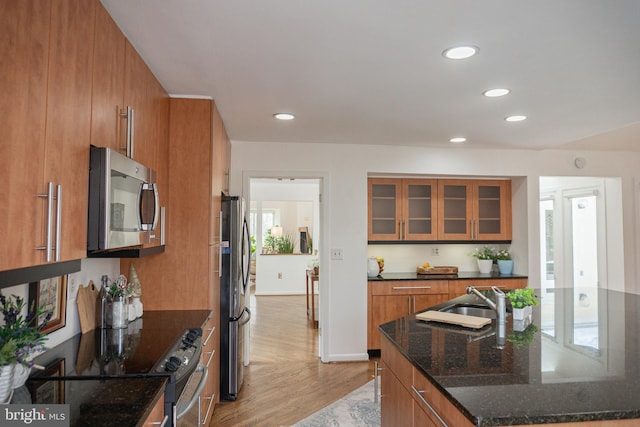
[29,275,68,334]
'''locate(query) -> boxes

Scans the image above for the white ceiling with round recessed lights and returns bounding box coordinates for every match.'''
[102,0,640,151]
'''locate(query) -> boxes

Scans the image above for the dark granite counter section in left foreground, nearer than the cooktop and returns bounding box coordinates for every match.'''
[11,377,167,427]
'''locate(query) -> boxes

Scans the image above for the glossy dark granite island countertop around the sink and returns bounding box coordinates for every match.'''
[379,289,640,426]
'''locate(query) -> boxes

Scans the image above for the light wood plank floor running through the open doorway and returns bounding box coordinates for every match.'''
[209,294,374,427]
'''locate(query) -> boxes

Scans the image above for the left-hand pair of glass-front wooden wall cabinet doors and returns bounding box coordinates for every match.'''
[368,178,438,241]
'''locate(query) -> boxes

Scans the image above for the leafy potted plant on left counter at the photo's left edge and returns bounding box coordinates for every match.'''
[0,293,52,403]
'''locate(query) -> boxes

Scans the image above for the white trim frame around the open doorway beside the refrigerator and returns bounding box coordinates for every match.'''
[242,170,332,362]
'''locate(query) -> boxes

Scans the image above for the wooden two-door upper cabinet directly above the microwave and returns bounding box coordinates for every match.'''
[91,2,169,171]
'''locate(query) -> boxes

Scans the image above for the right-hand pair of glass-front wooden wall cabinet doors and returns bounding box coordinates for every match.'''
[438,179,511,241]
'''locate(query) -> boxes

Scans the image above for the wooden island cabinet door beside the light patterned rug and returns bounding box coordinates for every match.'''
[380,362,414,427]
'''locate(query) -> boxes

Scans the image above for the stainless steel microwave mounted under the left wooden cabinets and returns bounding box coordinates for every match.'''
[87,146,160,253]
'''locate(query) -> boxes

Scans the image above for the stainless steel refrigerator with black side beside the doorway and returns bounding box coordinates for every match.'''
[220,196,251,400]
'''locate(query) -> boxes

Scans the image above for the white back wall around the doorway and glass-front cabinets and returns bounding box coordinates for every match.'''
[230,141,640,361]
